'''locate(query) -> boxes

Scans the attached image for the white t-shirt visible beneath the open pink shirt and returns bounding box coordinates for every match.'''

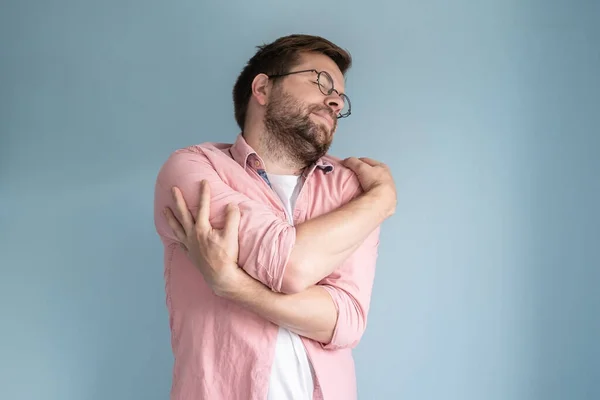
[267,174,314,400]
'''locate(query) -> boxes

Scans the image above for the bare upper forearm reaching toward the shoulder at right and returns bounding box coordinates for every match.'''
[282,188,388,293]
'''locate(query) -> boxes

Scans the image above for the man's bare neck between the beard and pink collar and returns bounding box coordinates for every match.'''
[244,127,307,175]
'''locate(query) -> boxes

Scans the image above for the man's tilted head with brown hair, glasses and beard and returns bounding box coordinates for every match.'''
[233,35,352,164]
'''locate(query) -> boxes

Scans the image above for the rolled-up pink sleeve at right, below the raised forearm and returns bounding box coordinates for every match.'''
[319,222,380,350]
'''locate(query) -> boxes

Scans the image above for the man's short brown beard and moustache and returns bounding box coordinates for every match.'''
[264,90,337,168]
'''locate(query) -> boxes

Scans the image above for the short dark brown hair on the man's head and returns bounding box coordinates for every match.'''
[233,34,352,130]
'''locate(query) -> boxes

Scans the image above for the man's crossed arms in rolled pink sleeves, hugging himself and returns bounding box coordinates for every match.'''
[152,148,386,349]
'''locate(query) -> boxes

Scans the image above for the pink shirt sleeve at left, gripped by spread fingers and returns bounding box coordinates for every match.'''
[154,150,296,292]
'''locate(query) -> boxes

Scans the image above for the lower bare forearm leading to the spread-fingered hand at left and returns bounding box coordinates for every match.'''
[217,269,337,344]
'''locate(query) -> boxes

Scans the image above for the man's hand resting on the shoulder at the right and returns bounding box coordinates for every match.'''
[343,157,397,218]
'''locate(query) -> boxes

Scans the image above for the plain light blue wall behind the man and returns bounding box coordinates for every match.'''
[0,0,600,400]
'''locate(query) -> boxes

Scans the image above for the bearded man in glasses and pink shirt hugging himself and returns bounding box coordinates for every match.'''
[155,35,396,400]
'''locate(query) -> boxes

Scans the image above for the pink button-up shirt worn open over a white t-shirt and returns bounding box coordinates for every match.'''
[154,135,379,400]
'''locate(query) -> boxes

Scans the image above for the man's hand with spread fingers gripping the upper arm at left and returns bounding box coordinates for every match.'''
[164,181,243,295]
